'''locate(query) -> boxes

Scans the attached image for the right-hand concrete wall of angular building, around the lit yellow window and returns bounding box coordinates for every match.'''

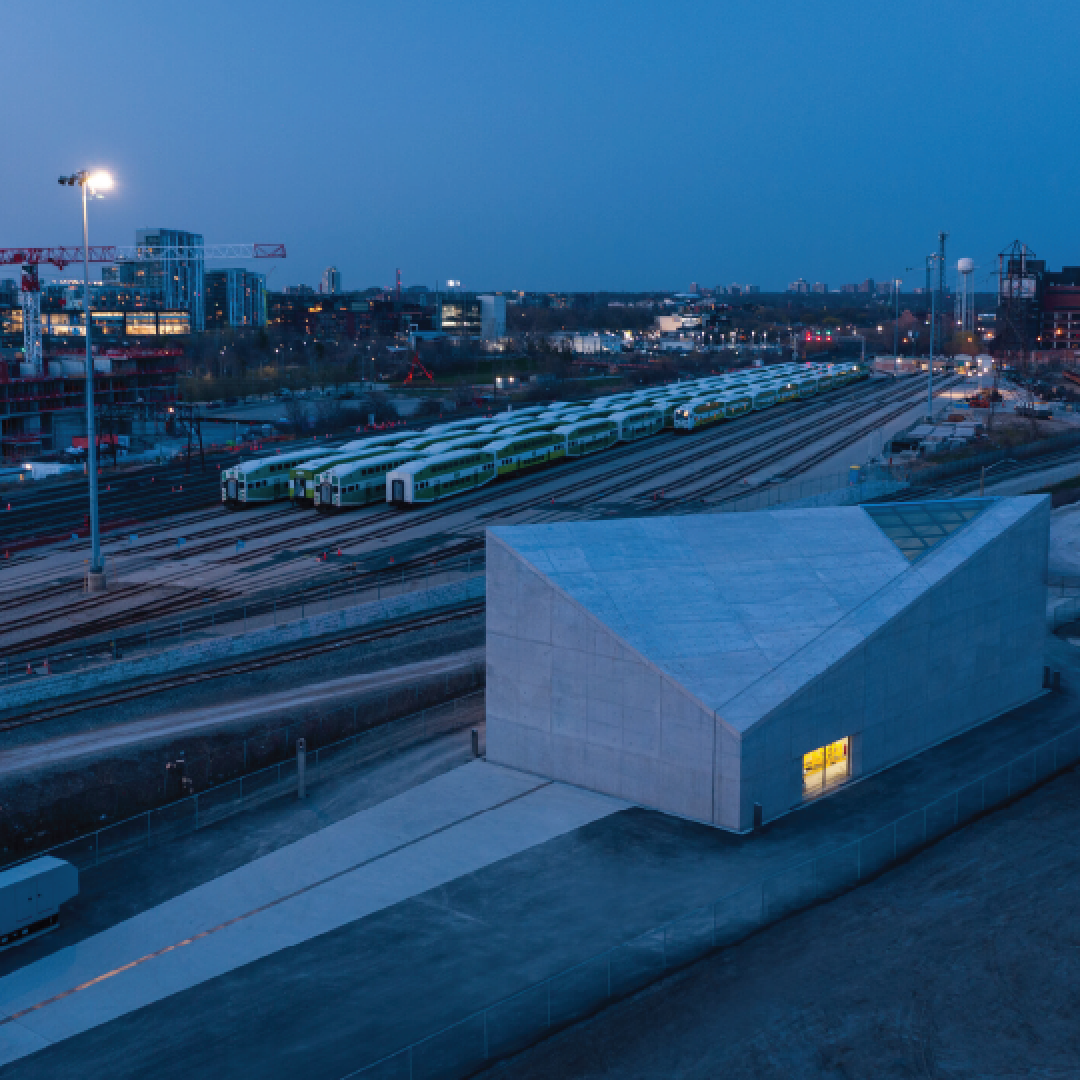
[739,498,1050,828]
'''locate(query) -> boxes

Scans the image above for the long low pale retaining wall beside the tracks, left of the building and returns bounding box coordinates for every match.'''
[0,577,485,708]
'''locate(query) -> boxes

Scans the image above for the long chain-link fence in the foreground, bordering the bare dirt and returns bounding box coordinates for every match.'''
[348,727,1080,1080]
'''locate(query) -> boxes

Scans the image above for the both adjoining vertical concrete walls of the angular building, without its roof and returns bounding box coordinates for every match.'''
[487,498,1050,831]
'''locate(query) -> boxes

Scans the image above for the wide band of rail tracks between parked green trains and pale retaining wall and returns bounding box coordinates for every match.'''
[0,379,947,674]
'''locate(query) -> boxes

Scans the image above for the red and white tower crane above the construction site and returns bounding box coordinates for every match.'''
[0,244,285,375]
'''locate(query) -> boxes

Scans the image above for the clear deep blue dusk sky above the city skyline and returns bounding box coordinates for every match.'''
[0,0,1080,289]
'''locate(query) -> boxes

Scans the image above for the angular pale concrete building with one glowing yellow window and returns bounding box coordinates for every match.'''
[487,496,1050,831]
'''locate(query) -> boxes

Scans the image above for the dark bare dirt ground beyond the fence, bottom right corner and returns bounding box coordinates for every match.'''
[492,770,1080,1080]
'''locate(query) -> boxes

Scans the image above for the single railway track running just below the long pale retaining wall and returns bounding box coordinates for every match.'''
[0,602,484,731]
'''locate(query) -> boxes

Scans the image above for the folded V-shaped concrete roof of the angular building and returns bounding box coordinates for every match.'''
[490,497,1044,732]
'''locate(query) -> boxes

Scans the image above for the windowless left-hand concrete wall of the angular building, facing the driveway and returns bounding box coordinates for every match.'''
[487,536,725,824]
